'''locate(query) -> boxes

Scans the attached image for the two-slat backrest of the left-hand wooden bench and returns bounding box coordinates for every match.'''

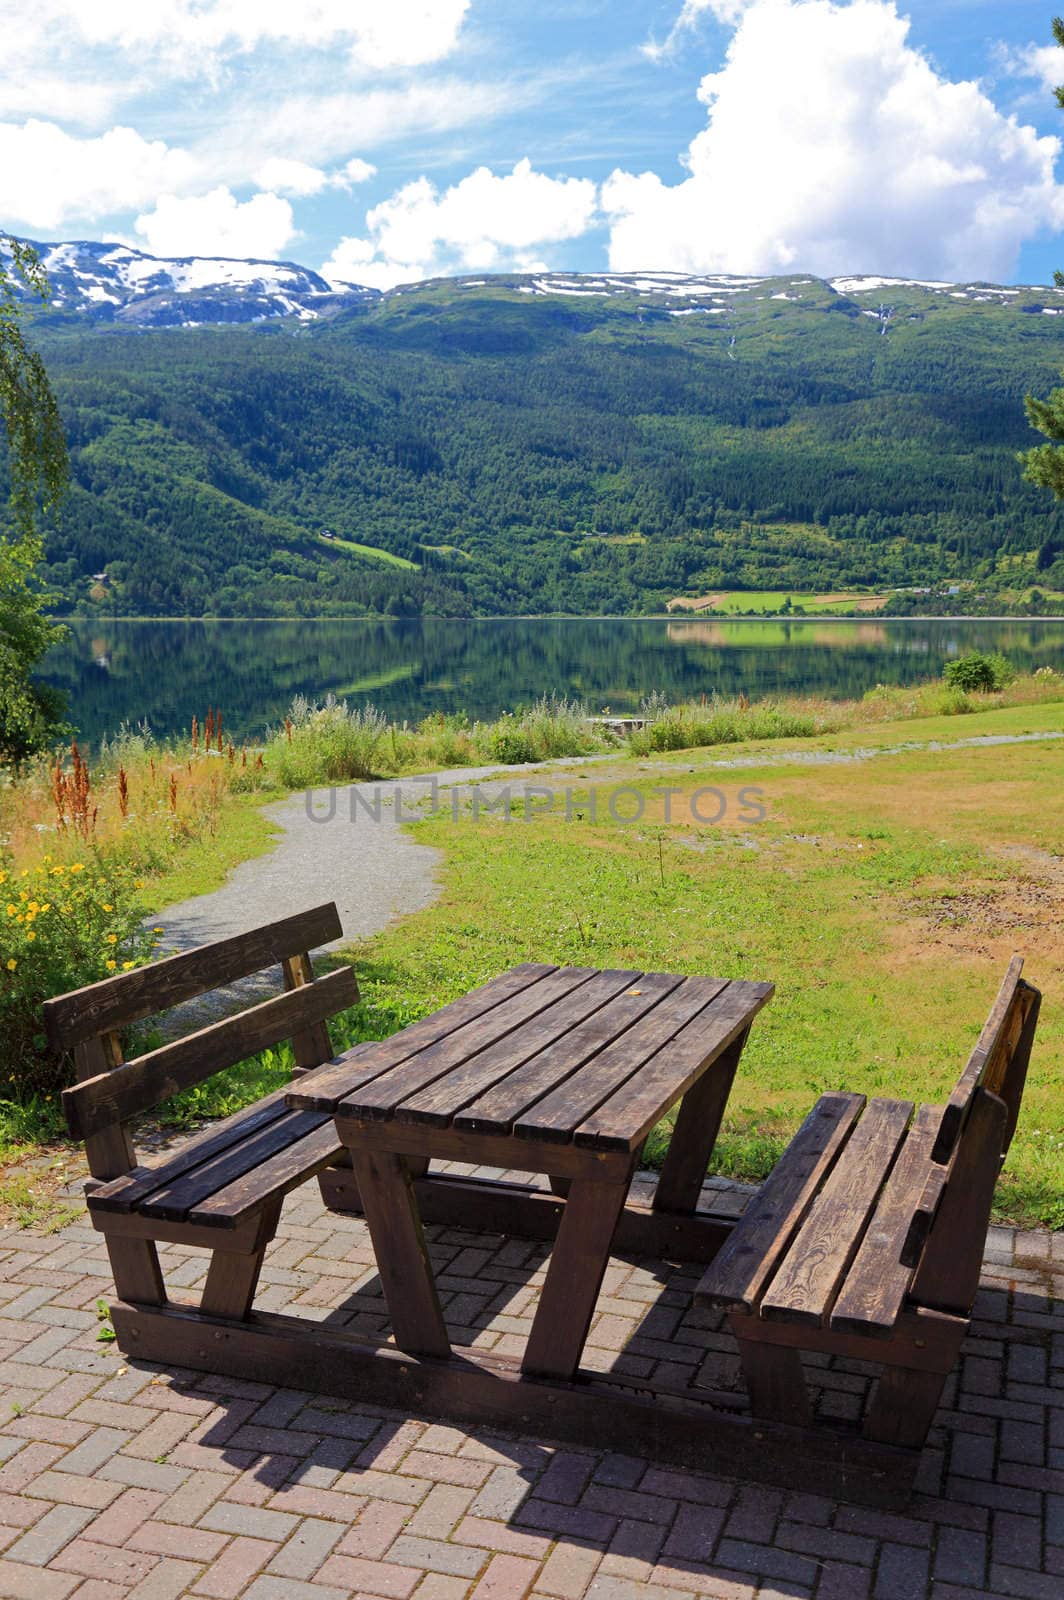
[43,904,358,1179]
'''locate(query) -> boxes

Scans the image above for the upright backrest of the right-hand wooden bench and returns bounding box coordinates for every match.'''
[902,955,1042,1315]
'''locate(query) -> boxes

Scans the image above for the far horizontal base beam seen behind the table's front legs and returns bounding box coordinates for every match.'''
[318,1166,733,1264]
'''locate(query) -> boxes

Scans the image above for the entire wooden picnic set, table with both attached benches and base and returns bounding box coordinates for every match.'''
[45,906,1040,1506]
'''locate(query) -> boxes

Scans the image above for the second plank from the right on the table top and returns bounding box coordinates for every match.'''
[514,978,728,1144]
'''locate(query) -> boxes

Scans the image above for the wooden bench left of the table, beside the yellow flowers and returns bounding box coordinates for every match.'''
[43,906,358,1318]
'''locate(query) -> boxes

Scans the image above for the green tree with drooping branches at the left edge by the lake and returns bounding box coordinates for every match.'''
[0,234,67,763]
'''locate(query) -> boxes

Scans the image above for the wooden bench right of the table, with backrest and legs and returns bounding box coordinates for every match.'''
[696,957,1040,1450]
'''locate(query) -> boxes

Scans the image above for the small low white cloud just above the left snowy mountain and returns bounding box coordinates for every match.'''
[134,187,294,261]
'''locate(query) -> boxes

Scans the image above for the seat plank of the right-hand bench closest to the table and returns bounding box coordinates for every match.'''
[694,1094,864,1310]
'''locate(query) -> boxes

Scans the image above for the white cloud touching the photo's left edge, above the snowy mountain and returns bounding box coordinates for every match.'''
[0,118,195,230]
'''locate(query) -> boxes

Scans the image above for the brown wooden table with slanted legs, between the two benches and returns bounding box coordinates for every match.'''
[288,963,773,1379]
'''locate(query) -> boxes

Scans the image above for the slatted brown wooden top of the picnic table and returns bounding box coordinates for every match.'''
[288,963,773,1150]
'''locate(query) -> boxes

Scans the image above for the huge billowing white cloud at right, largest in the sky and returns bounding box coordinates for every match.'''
[602,0,1064,278]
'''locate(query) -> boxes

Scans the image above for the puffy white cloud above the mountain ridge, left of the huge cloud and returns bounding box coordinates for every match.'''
[322,160,595,288]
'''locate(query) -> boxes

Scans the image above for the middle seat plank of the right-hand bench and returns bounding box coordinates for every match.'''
[762,1099,912,1328]
